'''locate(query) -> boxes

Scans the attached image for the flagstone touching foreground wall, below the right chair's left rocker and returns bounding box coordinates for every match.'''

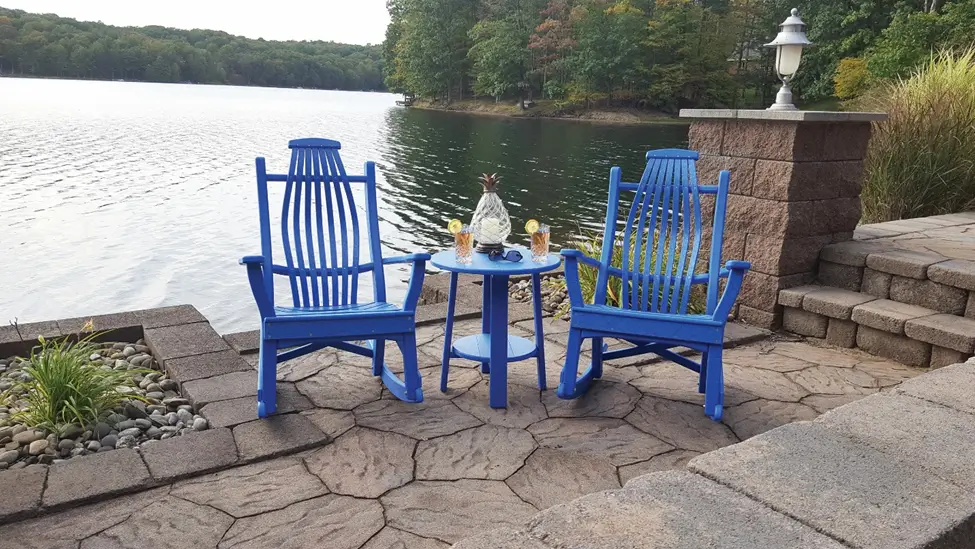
[506,448,620,509]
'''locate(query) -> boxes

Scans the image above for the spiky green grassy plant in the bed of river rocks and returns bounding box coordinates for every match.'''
[0,333,147,433]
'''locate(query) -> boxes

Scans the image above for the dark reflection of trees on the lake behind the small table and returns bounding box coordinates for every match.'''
[379,109,687,248]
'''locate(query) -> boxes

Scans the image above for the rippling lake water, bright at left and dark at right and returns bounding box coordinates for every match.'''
[0,78,687,333]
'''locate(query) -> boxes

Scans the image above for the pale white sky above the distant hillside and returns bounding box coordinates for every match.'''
[0,0,389,44]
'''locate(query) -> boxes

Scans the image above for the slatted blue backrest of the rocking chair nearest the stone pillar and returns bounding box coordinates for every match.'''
[595,149,729,315]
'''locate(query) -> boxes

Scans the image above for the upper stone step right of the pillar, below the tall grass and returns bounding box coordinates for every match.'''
[817,228,975,319]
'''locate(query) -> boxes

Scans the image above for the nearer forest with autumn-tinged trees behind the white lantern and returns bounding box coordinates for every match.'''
[383,0,975,112]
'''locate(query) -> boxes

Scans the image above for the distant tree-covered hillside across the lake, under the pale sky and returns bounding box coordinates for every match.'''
[0,7,385,90]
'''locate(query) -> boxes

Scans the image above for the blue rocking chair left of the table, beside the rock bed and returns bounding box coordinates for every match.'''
[240,139,430,417]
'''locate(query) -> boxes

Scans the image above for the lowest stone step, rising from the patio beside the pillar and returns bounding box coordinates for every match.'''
[779,285,975,368]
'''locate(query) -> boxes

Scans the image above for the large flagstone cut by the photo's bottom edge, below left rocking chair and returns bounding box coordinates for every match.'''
[220,494,383,549]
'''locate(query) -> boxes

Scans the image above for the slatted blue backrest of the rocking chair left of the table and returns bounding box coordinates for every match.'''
[256,139,386,308]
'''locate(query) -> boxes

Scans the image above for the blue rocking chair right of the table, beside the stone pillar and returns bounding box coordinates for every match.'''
[558,149,751,421]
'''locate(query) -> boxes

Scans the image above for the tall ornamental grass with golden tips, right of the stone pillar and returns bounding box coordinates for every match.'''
[861,48,975,223]
